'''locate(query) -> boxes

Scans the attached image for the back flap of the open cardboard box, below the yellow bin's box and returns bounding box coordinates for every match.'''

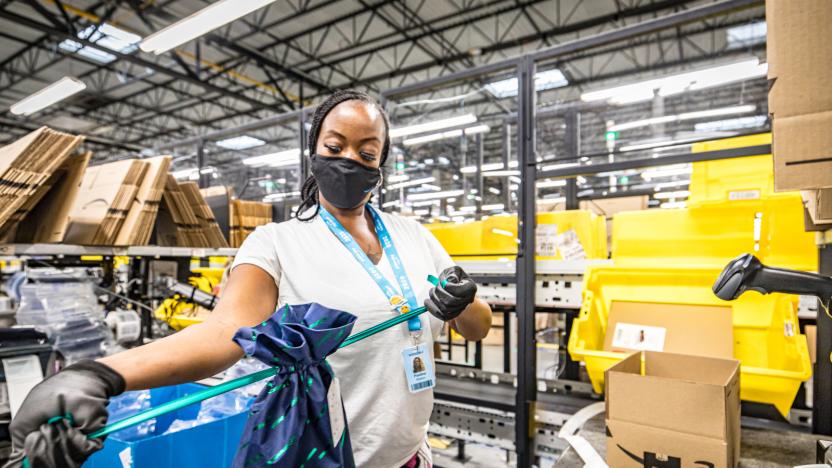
[644,351,740,386]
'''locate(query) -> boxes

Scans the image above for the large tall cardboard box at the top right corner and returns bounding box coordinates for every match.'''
[766,0,832,191]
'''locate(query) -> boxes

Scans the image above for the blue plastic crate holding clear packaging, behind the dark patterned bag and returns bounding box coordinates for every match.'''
[84,383,253,468]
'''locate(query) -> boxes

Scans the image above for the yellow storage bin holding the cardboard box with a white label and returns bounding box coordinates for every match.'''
[568,265,812,416]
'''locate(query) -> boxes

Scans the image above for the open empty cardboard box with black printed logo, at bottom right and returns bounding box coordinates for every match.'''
[606,351,740,468]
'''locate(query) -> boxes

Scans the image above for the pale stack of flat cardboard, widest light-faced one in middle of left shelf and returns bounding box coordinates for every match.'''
[64,159,150,245]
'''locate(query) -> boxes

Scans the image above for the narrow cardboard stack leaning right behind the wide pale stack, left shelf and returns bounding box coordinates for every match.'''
[114,156,171,245]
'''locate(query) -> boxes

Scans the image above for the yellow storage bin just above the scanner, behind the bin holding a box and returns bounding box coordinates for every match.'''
[612,194,818,271]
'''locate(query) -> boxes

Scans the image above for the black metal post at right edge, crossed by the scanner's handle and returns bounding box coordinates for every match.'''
[812,244,832,435]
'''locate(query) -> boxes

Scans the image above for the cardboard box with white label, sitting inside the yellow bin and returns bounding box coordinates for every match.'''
[604,301,734,359]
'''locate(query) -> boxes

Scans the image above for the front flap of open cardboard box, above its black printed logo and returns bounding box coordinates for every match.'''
[606,367,727,439]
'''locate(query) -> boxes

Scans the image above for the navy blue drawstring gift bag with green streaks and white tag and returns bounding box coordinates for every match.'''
[234,303,356,468]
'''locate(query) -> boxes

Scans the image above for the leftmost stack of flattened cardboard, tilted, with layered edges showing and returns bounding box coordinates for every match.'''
[0,127,83,236]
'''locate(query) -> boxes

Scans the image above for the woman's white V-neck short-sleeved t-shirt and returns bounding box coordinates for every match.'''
[232,209,453,468]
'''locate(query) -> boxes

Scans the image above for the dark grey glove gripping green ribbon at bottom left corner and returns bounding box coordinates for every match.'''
[6,361,125,468]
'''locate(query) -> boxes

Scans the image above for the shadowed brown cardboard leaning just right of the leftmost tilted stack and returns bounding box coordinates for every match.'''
[0,152,92,243]
